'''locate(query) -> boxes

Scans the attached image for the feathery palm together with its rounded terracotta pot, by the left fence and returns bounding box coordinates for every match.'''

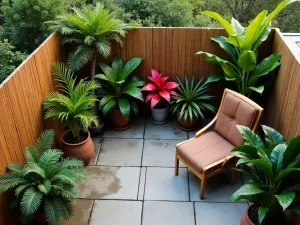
[43,62,100,165]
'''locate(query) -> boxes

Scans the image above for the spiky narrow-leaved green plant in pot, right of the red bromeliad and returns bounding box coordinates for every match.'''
[170,74,221,131]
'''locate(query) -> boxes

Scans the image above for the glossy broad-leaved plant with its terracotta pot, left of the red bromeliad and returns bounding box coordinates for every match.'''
[96,55,145,130]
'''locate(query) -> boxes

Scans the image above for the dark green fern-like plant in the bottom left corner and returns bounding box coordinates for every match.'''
[0,130,87,225]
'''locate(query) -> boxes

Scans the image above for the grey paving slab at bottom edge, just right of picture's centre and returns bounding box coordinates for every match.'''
[143,201,195,225]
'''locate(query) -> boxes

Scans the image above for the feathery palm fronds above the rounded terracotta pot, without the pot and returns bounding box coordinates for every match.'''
[43,62,100,141]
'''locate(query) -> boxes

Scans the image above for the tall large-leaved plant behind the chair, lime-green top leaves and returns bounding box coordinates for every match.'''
[197,0,299,96]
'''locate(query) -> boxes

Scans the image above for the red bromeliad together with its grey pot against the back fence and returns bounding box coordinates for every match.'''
[142,69,179,124]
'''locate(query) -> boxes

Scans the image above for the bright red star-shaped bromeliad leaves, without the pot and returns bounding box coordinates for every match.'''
[142,69,179,108]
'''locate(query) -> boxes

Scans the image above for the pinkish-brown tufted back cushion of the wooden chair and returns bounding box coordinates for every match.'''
[214,92,258,146]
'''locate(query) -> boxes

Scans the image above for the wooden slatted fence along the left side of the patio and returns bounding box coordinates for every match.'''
[0,34,64,225]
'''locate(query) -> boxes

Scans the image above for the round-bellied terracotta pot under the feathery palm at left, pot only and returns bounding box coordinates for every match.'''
[61,130,95,165]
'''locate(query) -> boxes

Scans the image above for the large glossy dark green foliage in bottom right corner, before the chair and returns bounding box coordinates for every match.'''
[230,125,300,224]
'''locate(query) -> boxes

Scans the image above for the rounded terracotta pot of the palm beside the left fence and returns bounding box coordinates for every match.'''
[62,130,95,165]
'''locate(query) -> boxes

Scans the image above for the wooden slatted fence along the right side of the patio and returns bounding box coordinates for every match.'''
[264,30,300,140]
